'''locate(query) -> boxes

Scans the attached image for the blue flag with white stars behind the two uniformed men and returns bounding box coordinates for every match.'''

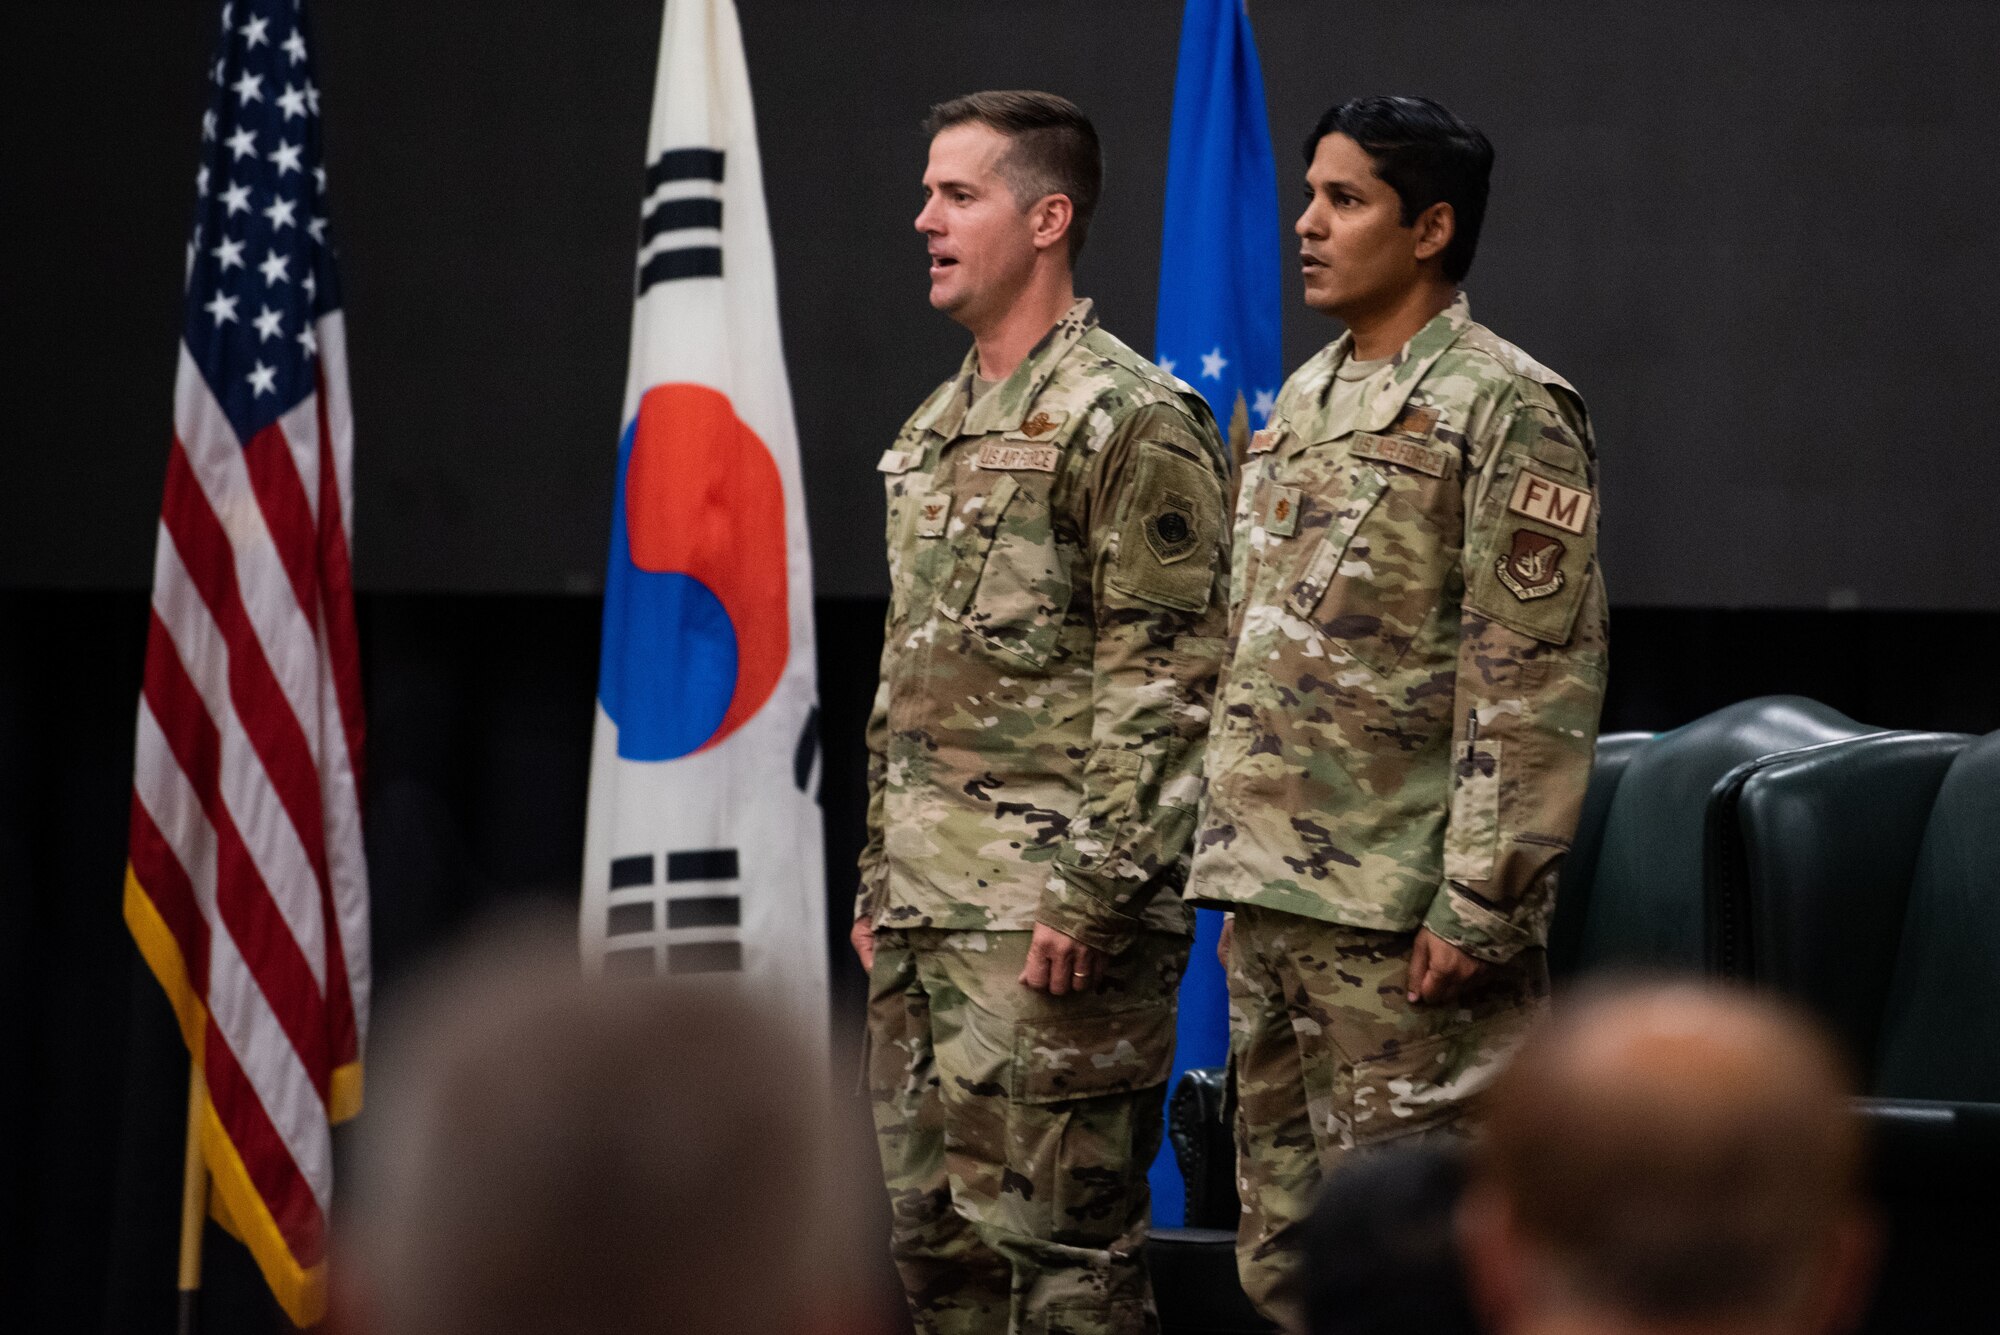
[1152,0,1284,1227]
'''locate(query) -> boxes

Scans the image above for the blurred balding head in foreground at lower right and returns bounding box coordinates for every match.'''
[1460,983,1876,1335]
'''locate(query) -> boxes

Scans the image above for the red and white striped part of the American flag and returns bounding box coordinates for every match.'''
[130,312,368,1271]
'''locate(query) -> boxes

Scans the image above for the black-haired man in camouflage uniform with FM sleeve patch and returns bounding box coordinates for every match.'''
[1188,98,1606,1325]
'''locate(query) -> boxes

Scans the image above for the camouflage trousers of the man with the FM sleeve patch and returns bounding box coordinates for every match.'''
[1228,905,1548,1331]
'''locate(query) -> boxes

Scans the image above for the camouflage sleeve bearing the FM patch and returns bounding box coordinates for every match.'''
[1424,394,1606,961]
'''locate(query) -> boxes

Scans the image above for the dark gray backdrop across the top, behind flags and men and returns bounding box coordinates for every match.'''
[15,0,2000,608]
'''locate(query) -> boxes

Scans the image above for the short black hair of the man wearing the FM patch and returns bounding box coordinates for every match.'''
[1306,98,1494,282]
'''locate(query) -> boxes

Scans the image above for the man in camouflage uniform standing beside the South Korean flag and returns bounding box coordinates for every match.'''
[854,94,1228,1335]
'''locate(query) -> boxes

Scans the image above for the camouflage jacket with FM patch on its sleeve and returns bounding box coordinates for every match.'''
[1188,296,1606,959]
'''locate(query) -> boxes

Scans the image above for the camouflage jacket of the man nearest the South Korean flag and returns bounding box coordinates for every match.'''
[856,300,1228,951]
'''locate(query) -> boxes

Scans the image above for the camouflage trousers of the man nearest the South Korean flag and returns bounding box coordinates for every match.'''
[868,929,1188,1335]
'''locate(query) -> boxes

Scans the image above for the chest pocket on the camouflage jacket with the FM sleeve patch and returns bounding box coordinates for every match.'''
[1286,438,1464,673]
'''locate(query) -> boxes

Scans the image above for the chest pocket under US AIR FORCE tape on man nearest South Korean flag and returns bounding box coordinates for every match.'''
[938,474,1070,668]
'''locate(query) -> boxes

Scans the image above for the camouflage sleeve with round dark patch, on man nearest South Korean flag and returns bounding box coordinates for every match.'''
[1036,404,1230,953]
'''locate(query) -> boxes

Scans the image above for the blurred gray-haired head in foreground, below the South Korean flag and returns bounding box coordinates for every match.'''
[332,933,868,1335]
